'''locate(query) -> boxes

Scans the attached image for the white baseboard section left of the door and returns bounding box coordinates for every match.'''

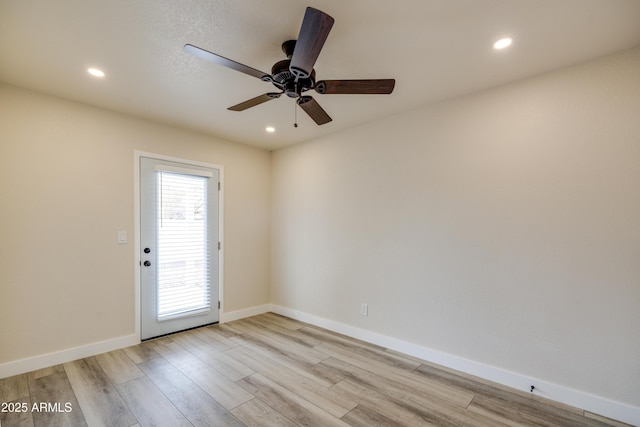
[0,335,140,378]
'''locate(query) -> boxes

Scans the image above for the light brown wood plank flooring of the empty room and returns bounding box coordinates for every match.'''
[0,313,625,427]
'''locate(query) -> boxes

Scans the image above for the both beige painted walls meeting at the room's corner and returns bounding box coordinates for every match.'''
[0,46,640,414]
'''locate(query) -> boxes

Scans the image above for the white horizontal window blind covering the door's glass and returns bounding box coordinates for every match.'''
[156,170,211,320]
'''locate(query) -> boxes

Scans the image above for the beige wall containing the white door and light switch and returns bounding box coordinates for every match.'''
[0,85,271,364]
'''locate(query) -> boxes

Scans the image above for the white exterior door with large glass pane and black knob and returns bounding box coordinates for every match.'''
[140,157,219,340]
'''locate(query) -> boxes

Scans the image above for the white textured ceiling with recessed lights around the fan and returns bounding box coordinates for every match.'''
[0,0,640,149]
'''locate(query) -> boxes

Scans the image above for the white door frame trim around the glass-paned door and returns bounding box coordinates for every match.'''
[133,150,224,339]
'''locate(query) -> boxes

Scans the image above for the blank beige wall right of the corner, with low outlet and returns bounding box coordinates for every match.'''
[271,49,640,407]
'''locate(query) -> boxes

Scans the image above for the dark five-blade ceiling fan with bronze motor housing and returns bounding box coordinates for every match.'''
[184,7,395,125]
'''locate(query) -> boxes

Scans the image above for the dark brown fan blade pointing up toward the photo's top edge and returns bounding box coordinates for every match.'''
[289,7,334,79]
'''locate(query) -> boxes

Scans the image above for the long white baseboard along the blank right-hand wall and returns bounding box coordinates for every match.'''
[271,305,640,426]
